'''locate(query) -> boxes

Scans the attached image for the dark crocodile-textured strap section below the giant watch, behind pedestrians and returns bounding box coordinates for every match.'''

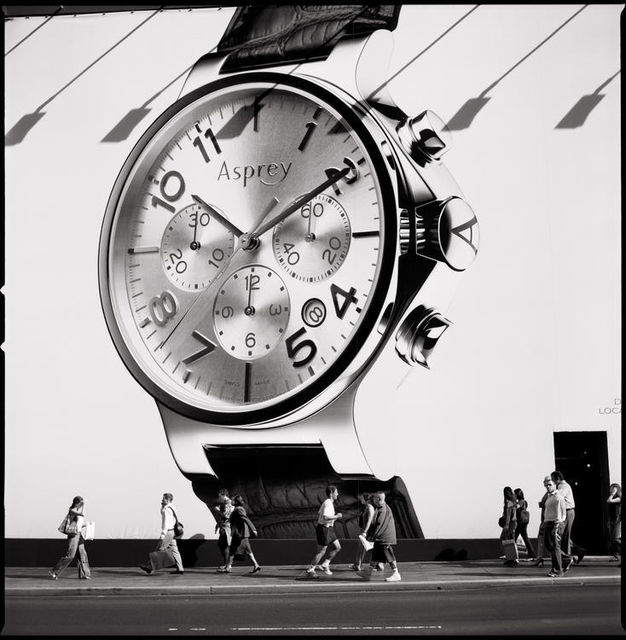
[185,445,424,539]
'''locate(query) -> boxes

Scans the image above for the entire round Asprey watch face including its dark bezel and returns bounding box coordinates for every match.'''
[100,73,397,424]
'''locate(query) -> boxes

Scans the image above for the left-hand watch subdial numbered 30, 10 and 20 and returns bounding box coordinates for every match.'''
[161,204,234,291]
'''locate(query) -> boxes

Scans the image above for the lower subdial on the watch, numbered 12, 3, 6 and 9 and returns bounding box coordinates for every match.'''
[213,264,289,361]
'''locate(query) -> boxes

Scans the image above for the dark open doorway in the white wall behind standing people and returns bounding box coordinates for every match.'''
[554,431,610,555]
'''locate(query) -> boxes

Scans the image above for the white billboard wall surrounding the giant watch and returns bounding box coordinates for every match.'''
[3,5,623,538]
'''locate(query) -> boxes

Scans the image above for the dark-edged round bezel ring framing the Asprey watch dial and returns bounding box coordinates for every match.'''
[98,71,398,426]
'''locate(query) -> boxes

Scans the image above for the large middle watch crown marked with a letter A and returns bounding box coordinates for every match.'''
[415,196,480,271]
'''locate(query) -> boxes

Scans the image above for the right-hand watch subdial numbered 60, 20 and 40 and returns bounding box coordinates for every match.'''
[273,193,351,282]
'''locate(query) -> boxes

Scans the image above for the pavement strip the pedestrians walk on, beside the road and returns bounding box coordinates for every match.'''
[4,556,621,597]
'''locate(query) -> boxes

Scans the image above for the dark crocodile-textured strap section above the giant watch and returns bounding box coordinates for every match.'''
[217,4,400,73]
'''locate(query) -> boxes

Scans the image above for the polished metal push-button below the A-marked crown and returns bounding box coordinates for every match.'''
[396,305,452,369]
